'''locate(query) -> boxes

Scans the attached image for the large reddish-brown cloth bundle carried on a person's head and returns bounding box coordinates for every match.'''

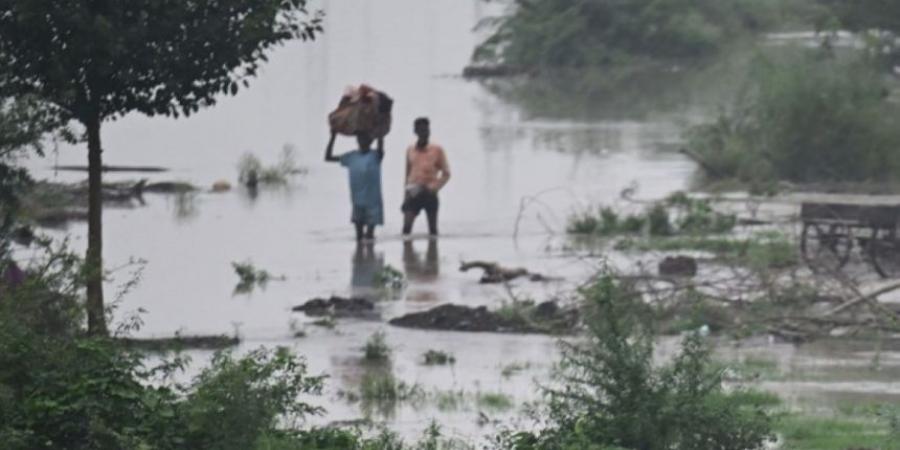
[328,84,394,138]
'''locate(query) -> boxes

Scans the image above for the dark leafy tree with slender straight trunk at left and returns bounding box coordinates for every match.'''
[0,0,322,334]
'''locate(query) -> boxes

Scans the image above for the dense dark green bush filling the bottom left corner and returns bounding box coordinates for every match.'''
[0,244,321,450]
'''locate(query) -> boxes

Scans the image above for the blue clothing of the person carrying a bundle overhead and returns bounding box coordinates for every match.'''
[341,150,384,225]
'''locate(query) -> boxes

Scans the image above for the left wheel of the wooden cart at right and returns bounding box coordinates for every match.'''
[800,223,853,273]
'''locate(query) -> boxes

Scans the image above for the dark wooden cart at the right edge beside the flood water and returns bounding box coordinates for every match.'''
[800,203,900,278]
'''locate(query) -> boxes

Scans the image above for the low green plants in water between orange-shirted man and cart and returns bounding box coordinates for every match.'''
[567,192,736,236]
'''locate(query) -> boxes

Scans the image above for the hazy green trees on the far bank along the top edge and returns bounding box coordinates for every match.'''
[474,0,816,68]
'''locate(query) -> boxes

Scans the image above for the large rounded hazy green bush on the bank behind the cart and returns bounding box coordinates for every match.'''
[687,53,900,185]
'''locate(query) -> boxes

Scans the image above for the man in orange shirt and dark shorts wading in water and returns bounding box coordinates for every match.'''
[401,117,450,236]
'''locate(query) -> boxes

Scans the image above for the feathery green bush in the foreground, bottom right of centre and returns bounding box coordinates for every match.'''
[501,276,772,450]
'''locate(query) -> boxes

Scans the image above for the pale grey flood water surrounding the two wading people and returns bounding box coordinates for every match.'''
[21,0,898,442]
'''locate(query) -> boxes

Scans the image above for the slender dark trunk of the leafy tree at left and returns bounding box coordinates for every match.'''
[85,117,108,336]
